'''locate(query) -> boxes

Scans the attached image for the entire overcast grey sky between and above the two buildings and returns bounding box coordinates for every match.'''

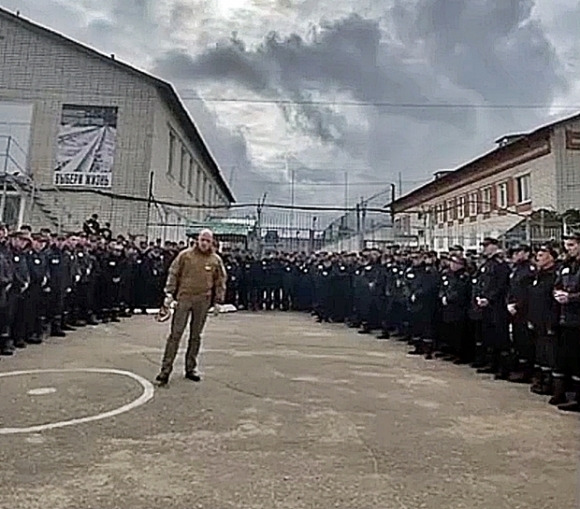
[0,0,580,210]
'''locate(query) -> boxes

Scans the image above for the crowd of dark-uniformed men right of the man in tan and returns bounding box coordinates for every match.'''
[223,234,580,411]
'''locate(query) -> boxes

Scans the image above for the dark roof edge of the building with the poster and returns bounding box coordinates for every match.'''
[0,7,236,203]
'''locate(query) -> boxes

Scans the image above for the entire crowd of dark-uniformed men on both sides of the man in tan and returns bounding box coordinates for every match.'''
[5,210,580,411]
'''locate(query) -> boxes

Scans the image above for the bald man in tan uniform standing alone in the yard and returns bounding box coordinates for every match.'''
[155,230,226,386]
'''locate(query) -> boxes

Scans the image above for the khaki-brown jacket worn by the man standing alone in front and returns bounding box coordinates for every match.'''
[165,246,227,301]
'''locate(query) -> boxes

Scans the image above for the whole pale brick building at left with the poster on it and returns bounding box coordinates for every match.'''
[0,9,234,238]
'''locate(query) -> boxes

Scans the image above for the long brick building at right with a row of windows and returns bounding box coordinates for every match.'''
[392,115,580,251]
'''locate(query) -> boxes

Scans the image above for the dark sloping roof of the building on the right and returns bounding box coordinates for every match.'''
[386,113,580,212]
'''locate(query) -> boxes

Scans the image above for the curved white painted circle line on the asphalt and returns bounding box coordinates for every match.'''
[0,368,155,435]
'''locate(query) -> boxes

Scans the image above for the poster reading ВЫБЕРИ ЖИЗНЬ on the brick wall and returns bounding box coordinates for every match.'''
[54,104,117,188]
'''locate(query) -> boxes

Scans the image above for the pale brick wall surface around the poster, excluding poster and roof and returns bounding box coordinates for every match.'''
[0,13,231,233]
